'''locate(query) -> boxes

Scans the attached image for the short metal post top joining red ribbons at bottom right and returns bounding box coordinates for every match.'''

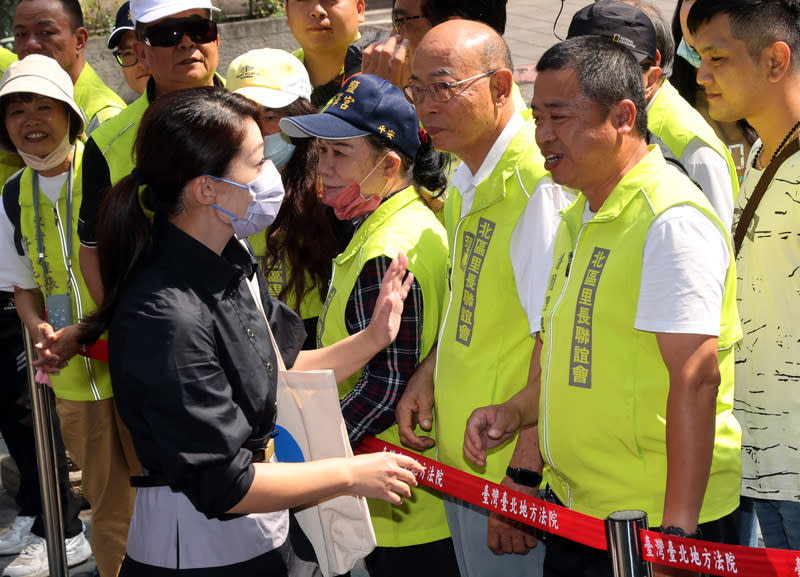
[605,511,653,577]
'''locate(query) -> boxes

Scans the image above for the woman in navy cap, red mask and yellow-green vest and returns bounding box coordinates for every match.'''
[280,74,458,577]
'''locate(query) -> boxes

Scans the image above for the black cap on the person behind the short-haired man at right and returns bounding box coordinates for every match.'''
[567,0,656,62]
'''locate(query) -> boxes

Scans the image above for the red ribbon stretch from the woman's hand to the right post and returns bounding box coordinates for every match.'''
[359,437,608,549]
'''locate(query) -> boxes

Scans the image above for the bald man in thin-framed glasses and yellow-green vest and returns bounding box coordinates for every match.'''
[397,20,572,577]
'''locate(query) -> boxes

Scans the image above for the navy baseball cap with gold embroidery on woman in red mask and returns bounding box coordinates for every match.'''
[280,74,420,159]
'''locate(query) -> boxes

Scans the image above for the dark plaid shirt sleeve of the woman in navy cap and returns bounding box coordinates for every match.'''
[341,256,422,448]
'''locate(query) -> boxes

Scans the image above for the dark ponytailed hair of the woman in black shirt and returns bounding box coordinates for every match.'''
[80,86,259,344]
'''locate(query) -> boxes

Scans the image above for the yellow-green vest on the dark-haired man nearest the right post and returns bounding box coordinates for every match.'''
[539,146,742,525]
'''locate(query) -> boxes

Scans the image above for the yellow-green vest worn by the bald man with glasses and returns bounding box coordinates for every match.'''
[435,120,547,482]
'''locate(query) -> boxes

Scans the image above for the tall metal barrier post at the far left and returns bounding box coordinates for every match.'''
[23,325,69,577]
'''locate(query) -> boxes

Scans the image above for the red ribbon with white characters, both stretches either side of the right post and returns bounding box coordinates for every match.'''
[358,437,800,577]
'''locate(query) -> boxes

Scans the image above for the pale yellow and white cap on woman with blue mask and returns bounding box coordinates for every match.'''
[225,48,311,108]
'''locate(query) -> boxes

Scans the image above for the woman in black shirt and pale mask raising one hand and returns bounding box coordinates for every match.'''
[85,88,421,576]
